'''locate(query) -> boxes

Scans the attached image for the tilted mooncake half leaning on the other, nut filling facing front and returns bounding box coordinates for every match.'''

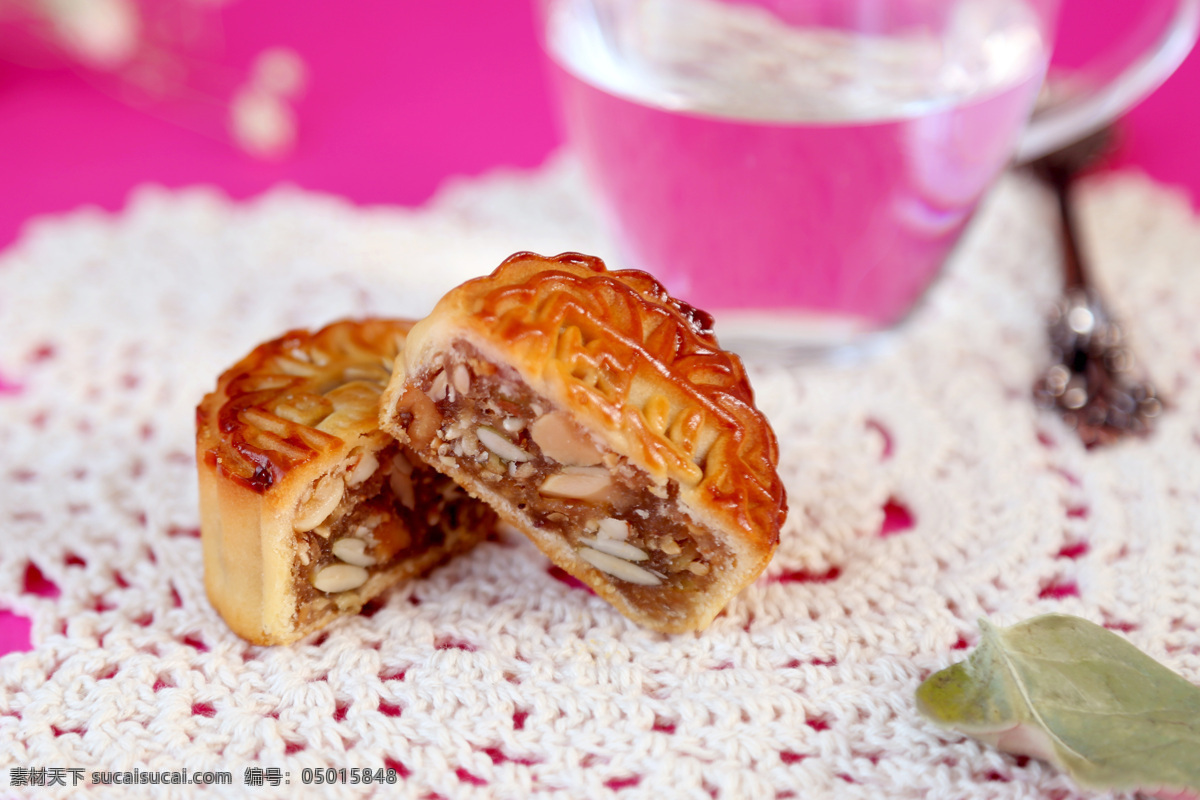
[380,253,787,632]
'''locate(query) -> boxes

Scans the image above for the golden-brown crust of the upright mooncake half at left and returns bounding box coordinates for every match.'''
[197,319,486,644]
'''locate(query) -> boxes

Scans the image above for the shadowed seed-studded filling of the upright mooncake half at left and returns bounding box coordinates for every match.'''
[294,434,485,618]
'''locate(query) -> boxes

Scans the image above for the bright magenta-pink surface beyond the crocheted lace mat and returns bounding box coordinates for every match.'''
[0,0,1200,654]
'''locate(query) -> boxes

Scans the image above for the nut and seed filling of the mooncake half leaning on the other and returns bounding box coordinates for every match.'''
[400,343,732,601]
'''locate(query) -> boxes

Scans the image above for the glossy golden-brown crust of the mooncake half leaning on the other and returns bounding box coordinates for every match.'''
[382,253,787,630]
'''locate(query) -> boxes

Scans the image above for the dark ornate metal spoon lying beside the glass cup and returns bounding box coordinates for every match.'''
[1030,128,1163,447]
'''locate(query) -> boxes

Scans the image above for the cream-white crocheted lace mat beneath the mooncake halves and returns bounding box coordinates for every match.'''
[0,153,1200,799]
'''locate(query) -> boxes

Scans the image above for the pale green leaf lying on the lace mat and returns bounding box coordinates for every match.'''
[917,614,1200,796]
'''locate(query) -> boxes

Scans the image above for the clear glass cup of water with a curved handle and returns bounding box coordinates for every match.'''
[539,0,1200,360]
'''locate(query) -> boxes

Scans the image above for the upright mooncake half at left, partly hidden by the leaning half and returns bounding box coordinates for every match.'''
[196,319,494,644]
